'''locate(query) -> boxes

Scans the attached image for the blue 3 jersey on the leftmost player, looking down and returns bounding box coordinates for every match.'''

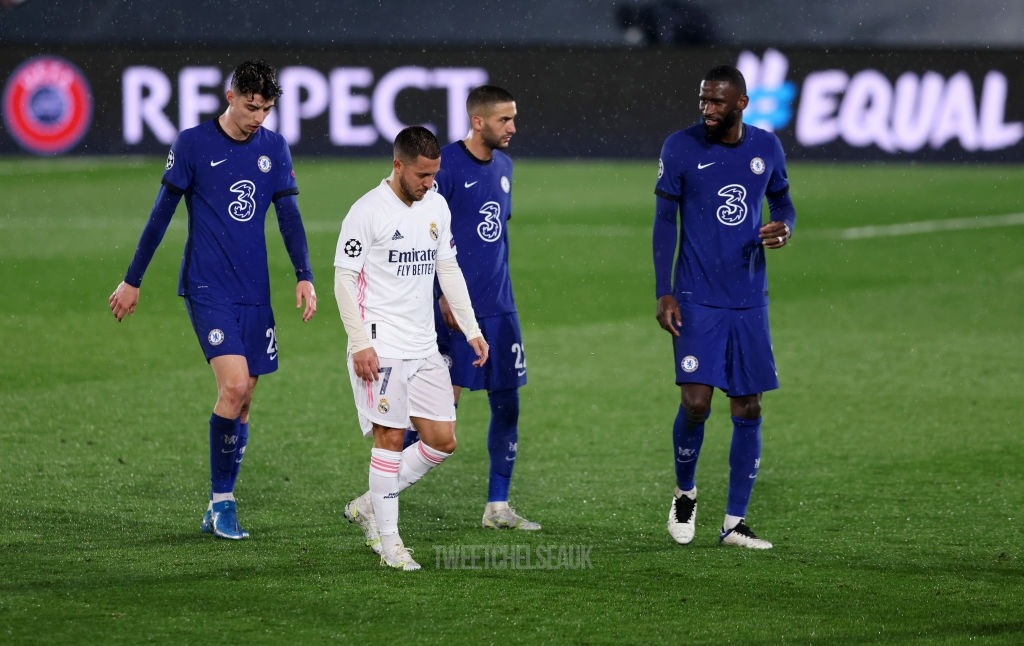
[162,119,299,305]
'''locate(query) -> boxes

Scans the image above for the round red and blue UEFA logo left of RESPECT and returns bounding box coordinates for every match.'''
[2,56,92,155]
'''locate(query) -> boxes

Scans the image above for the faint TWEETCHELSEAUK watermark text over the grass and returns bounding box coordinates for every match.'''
[431,545,594,570]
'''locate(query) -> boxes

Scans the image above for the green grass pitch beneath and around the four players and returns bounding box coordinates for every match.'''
[0,159,1024,645]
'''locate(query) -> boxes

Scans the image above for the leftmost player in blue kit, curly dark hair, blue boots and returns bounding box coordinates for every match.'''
[109,60,316,540]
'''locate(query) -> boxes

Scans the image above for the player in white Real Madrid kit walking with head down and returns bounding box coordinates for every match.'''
[334,126,488,570]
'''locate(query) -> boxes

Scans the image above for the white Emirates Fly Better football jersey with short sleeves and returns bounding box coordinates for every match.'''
[334,179,456,359]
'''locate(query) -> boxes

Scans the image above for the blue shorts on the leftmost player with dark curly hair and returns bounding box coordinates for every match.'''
[184,296,278,377]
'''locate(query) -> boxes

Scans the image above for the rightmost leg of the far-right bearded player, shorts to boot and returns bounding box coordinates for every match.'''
[719,308,778,550]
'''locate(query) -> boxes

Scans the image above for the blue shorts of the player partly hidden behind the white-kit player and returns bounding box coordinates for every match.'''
[434,307,526,392]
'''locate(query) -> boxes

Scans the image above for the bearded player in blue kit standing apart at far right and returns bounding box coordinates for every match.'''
[653,66,797,550]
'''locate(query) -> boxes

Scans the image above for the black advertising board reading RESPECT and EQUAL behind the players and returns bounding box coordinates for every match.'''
[0,47,1024,162]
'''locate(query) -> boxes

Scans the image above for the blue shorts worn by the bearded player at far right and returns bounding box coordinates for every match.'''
[672,301,778,397]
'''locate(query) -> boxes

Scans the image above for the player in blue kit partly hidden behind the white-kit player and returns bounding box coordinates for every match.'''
[406,85,541,530]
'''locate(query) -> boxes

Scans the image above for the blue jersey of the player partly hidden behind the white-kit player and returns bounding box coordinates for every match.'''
[435,141,515,318]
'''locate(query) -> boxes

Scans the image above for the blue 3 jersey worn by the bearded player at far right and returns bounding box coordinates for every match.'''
[654,124,788,308]
